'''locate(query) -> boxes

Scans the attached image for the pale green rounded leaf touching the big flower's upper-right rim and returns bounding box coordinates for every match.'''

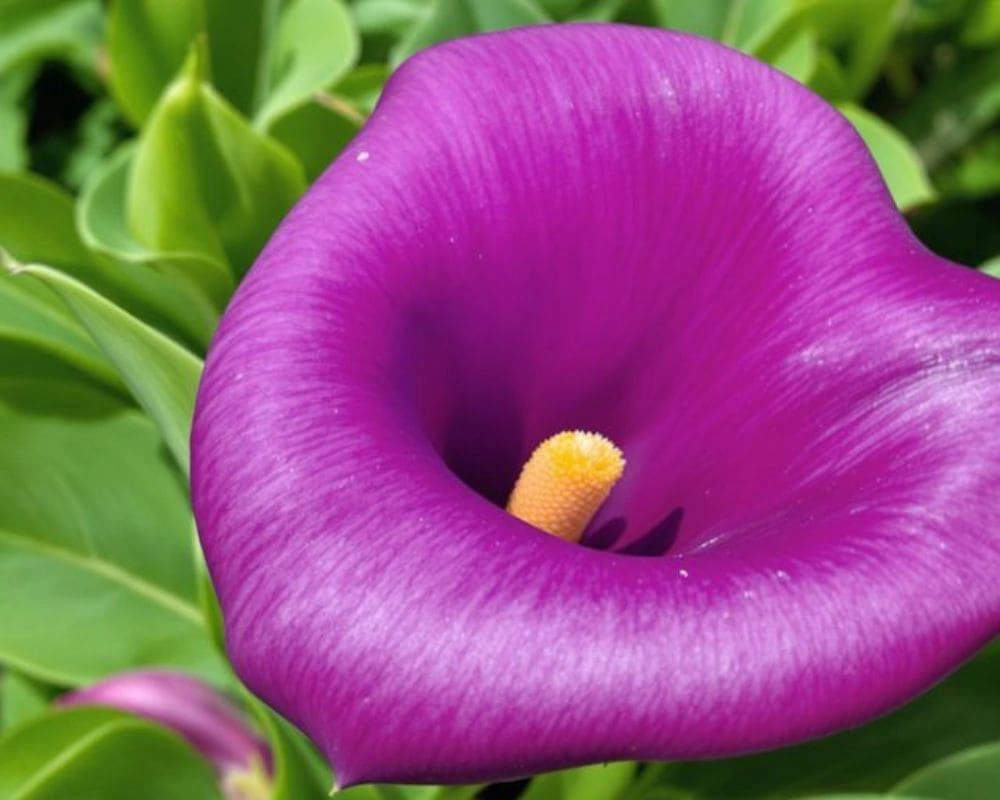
[840,105,934,211]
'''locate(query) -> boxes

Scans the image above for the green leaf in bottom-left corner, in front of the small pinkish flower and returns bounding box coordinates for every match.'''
[0,708,221,800]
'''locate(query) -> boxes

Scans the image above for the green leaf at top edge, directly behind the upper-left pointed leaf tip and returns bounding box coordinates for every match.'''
[108,0,204,127]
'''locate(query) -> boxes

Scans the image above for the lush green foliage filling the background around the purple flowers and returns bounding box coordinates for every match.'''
[0,0,1000,800]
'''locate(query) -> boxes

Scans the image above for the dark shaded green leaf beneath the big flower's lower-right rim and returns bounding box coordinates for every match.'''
[666,642,1000,800]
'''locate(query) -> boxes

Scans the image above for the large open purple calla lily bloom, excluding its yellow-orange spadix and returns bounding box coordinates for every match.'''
[193,26,1000,785]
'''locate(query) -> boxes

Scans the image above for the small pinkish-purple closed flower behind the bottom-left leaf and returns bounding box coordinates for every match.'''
[57,669,271,800]
